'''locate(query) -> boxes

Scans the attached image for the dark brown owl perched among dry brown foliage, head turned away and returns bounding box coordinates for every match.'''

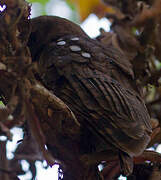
[28,16,151,174]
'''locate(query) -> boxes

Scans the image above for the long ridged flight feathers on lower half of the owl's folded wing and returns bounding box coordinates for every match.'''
[64,72,150,154]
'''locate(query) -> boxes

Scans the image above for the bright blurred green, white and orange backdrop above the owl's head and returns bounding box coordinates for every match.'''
[29,0,109,37]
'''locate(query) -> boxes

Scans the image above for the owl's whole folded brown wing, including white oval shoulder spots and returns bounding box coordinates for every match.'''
[40,37,151,156]
